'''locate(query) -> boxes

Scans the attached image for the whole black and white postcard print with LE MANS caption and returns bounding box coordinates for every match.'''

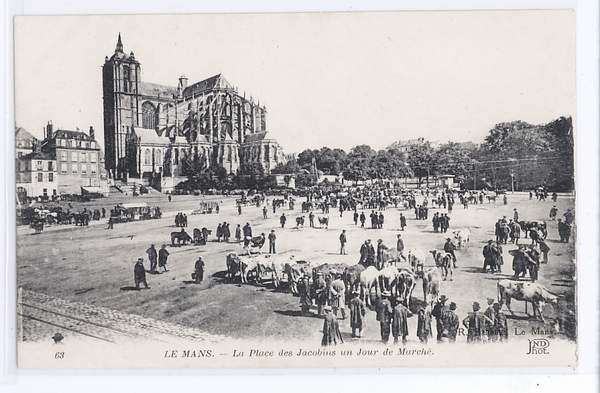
[9,9,576,368]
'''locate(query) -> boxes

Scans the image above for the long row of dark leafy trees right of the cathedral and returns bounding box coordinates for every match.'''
[273,117,574,191]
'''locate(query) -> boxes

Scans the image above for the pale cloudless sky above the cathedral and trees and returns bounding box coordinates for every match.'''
[15,10,576,153]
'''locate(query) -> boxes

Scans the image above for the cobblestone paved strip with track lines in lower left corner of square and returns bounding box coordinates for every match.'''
[17,289,223,343]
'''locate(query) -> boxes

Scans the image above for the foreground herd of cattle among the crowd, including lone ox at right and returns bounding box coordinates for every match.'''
[219,222,561,321]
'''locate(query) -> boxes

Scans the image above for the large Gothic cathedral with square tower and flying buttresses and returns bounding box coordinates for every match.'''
[102,34,285,191]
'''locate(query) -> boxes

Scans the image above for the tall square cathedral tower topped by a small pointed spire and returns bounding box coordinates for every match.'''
[102,33,141,180]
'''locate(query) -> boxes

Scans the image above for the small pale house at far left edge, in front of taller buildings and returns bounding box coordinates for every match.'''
[15,151,58,197]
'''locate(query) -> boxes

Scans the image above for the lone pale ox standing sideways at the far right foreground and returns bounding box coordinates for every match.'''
[497,280,560,322]
